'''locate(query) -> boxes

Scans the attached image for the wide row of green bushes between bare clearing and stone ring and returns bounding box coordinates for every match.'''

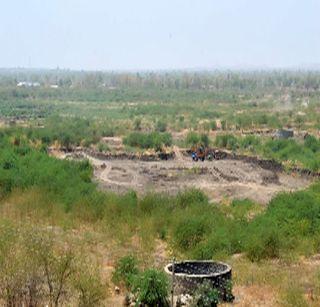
[172,184,320,261]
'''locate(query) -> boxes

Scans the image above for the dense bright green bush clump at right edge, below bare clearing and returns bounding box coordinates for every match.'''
[246,184,320,261]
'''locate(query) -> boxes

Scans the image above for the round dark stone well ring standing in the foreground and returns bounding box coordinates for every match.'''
[165,260,233,301]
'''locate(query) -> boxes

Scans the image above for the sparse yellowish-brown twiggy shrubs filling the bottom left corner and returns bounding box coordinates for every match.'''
[0,222,104,306]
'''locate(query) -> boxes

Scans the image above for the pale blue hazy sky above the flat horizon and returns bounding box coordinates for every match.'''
[0,0,320,70]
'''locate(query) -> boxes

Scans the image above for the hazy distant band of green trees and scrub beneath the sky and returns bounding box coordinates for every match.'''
[0,70,319,139]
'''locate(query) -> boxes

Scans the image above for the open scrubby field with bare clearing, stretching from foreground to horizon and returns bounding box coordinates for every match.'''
[0,70,320,306]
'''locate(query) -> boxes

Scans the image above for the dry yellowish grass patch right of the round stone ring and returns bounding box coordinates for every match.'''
[225,257,320,307]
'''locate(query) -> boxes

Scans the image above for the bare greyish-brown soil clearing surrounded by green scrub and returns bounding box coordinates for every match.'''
[87,149,312,204]
